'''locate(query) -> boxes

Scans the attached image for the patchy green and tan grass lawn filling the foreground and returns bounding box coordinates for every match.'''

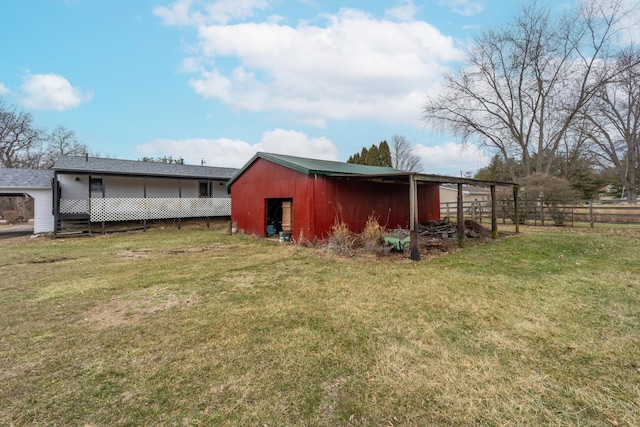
[0,222,640,426]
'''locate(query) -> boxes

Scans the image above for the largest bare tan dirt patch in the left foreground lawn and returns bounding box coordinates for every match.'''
[84,288,200,330]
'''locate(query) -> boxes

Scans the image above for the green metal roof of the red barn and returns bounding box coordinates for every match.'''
[227,152,407,186]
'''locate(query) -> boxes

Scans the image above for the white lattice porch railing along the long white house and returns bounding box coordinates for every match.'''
[60,197,231,222]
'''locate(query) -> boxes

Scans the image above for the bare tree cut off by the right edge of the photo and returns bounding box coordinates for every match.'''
[581,48,640,203]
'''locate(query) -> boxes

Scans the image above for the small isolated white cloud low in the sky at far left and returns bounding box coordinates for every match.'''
[19,74,93,111]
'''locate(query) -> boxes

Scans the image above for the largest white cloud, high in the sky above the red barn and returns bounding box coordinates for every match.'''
[178,7,461,125]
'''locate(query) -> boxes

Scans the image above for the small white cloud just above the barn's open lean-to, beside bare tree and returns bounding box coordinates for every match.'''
[413,142,491,176]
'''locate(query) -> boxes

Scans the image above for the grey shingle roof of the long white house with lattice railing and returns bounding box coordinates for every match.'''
[53,156,238,179]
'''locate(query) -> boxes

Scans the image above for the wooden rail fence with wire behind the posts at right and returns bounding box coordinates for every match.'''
[440,199,640,226]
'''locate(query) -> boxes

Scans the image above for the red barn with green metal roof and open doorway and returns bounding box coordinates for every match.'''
[227,153,440,240]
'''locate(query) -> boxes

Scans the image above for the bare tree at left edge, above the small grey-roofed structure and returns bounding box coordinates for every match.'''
[0,99,45,168]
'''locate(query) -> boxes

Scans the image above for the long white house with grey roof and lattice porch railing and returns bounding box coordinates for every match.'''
[52,156,237,232]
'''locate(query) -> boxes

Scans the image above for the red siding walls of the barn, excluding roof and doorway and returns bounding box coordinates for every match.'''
[231,158,440,239]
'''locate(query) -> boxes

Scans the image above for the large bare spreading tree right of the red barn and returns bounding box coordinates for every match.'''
[423,0,624,179]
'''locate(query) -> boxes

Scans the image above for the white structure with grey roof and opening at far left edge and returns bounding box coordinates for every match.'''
[0,168,54,233]
